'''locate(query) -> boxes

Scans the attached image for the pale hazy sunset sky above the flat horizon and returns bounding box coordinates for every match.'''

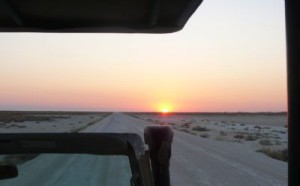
[0,0,287,112]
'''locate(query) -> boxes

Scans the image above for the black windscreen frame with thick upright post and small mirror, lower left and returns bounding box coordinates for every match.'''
[0,126,173,186]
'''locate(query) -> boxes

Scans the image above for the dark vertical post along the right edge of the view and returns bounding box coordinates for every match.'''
[285,0,300,186]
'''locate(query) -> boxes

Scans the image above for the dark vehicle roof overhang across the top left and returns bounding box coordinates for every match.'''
[0,0,202,33]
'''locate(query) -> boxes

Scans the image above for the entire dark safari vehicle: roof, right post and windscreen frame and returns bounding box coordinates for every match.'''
[0,0,300,185]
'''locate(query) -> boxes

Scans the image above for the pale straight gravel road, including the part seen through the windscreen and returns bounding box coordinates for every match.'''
[0,113,287,186]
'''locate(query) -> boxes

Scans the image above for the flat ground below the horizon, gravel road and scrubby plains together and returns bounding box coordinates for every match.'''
[0,112,288,186]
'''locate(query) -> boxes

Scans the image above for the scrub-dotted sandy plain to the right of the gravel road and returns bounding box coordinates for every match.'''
[131,114,287,151]
